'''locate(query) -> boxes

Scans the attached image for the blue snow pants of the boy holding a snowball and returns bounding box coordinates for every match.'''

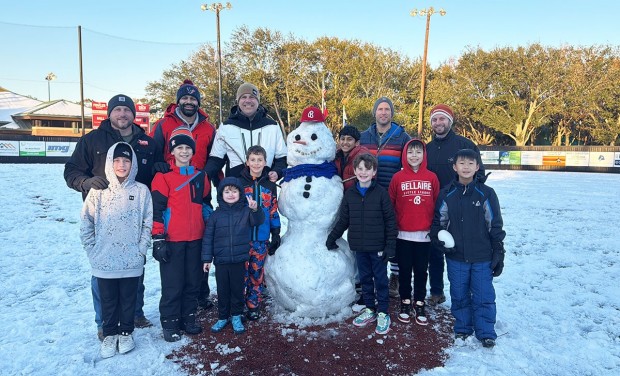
[446,258,497,340]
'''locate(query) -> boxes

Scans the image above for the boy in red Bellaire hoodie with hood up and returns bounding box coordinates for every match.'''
[389,139,439,325]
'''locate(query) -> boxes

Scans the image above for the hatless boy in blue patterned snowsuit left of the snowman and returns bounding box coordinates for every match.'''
[240,145,280,321]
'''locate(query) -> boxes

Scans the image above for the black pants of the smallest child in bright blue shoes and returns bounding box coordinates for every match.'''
[215,262,245,320]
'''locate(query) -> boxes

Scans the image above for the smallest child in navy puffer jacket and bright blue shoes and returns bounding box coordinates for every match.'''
[202,177,265,334]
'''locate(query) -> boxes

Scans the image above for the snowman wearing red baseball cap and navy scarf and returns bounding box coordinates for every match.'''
[265,107,355,318]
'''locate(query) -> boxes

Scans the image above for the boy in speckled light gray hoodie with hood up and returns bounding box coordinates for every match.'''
[80,142,153,358]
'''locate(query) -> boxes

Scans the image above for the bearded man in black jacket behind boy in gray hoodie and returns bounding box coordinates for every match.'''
[64,94,163,339]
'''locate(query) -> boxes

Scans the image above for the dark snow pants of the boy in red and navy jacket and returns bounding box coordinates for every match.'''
[159,240,202,323]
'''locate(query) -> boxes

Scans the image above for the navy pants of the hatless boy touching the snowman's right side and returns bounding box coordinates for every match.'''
[355,252,390,313]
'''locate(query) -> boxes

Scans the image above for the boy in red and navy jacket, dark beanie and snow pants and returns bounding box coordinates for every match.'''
[152,127,212,342]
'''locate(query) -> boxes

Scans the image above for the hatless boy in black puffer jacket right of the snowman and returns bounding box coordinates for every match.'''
[325,154,397,334]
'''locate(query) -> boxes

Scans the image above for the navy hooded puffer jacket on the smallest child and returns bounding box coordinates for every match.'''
[202,176,265,265]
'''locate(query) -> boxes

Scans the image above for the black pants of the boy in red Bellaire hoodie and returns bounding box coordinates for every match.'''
[396,239,431,302]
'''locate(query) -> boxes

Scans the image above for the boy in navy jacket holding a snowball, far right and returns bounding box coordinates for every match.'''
[430,149,506,347]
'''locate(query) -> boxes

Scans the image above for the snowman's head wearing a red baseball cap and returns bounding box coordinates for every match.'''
[286,107,336,166]
